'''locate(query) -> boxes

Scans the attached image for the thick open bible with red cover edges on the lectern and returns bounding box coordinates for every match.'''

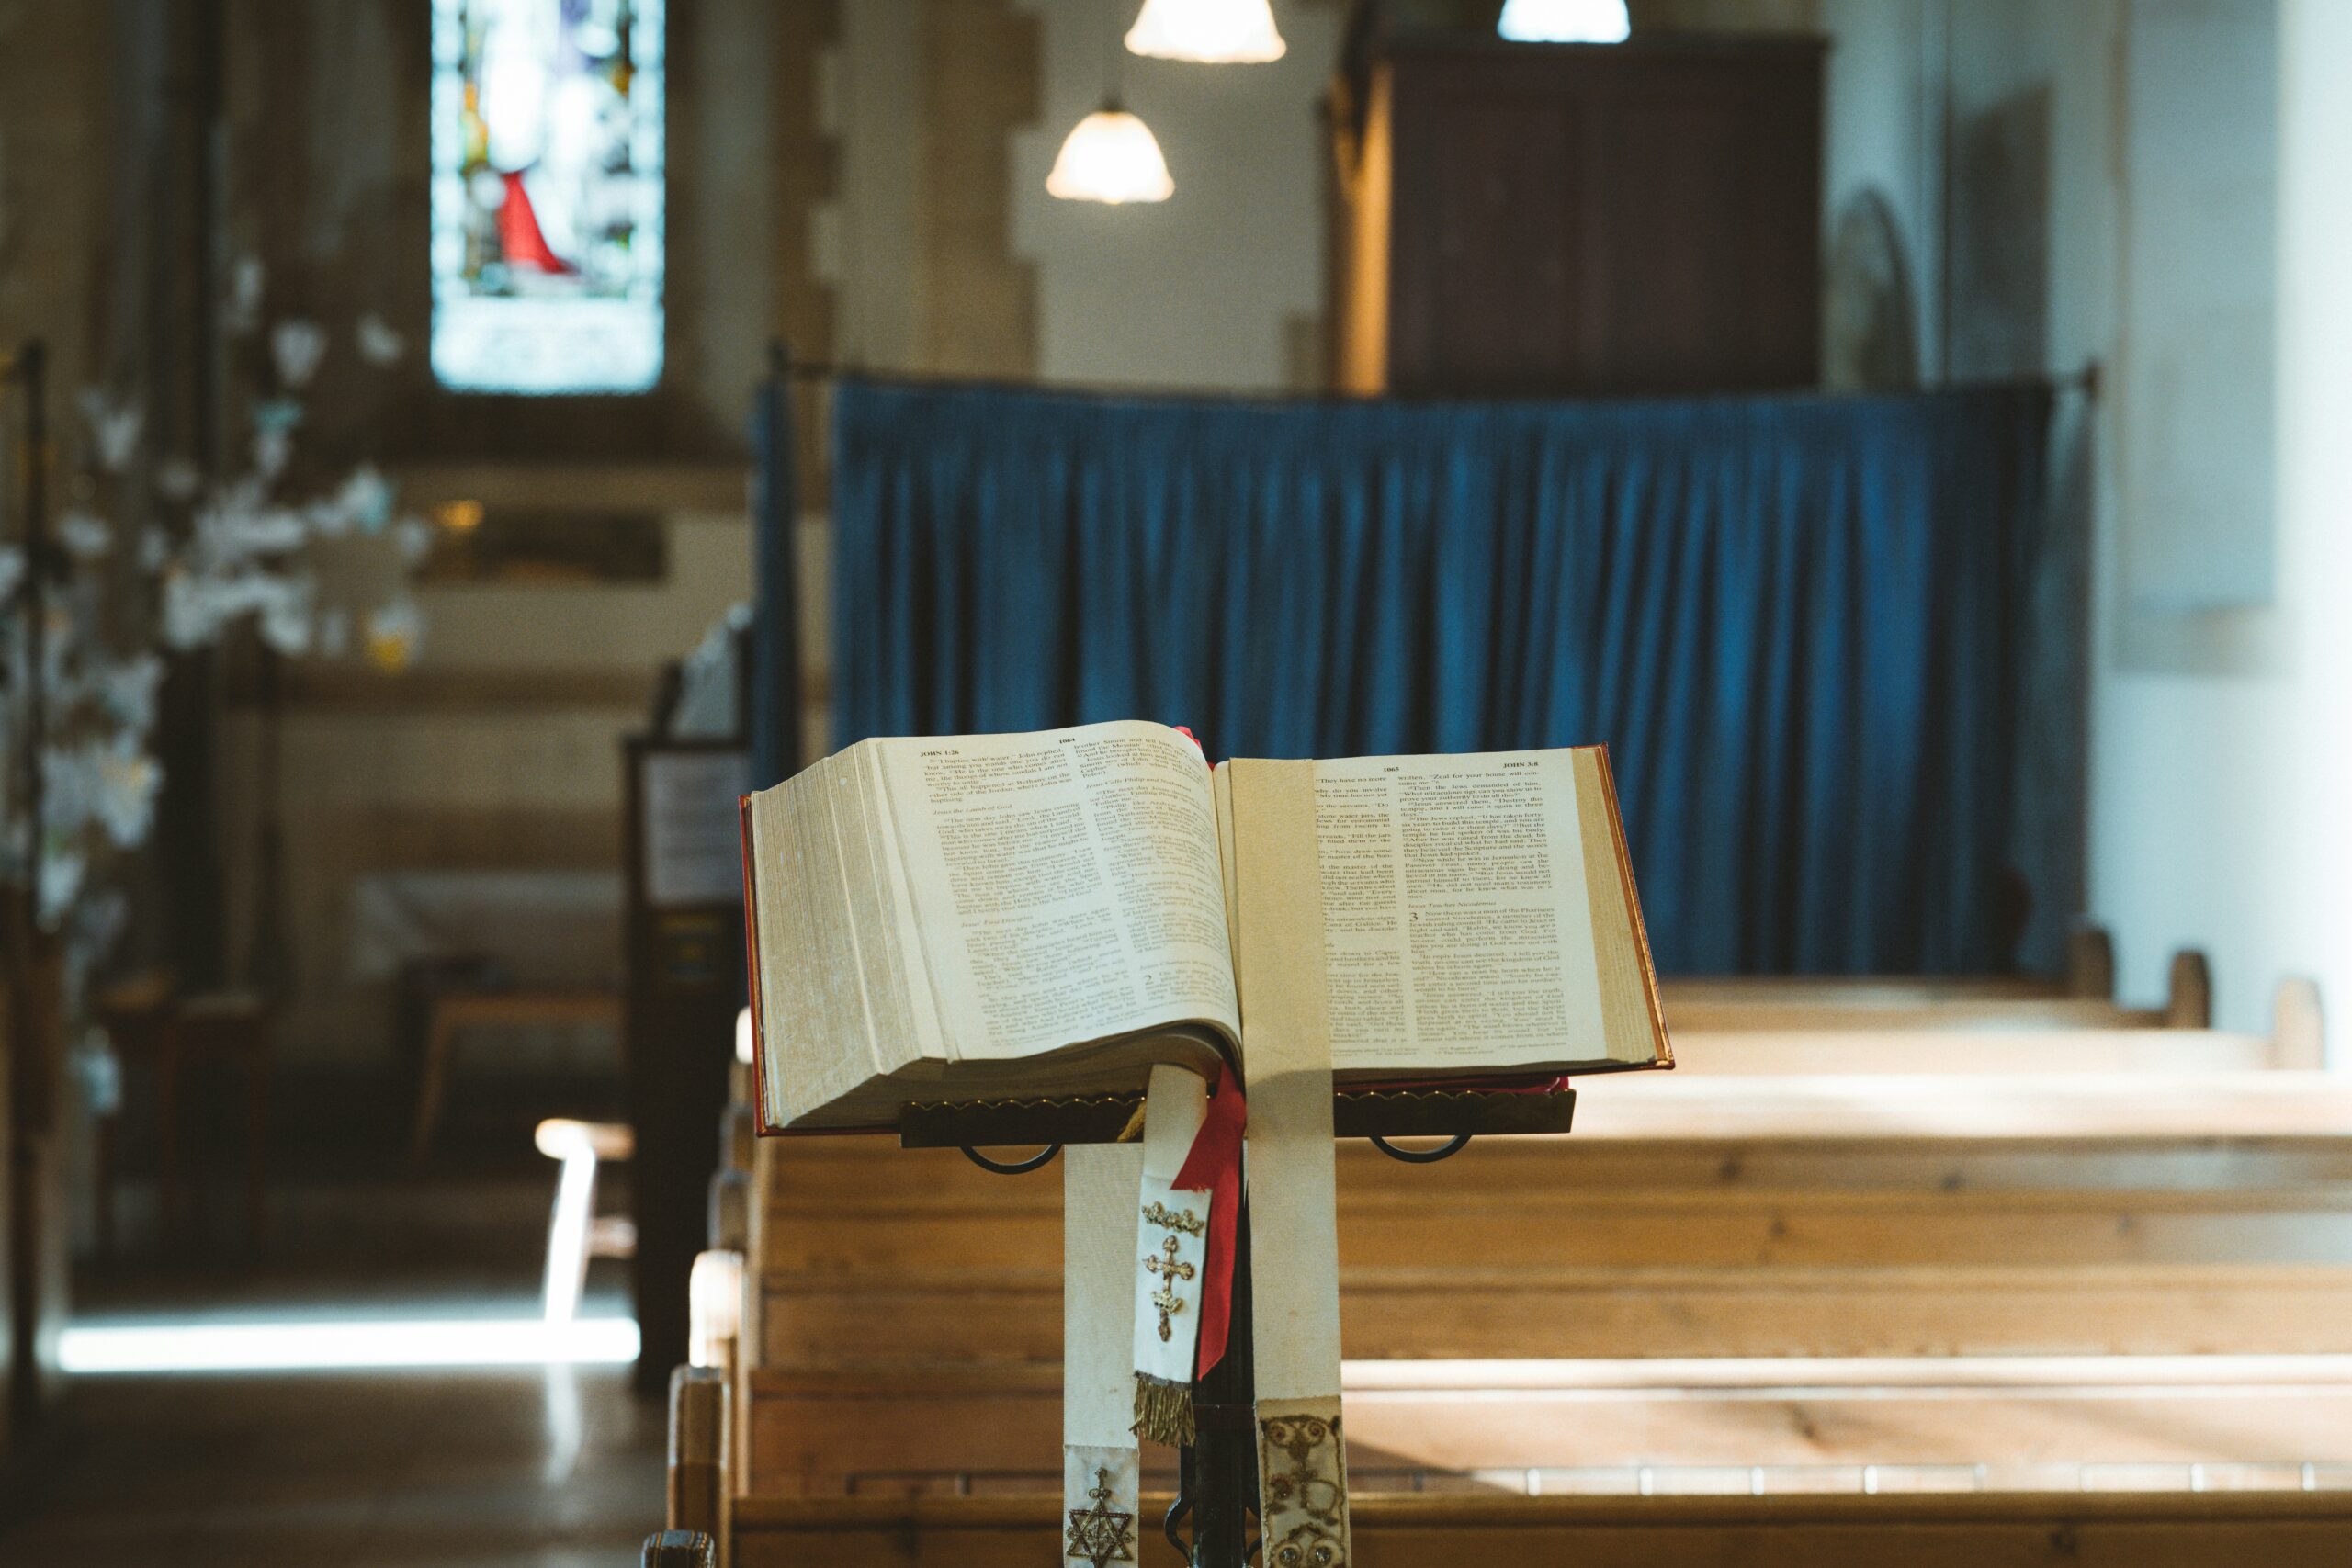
[743,722,1672,1131]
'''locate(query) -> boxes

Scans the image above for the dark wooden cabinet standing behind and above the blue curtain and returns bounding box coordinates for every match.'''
[1331,35,1826,395]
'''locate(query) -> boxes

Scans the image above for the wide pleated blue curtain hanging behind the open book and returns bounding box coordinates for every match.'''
[832,381,2049,974]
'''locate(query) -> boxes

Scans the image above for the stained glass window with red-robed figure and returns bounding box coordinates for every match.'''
[430,0,663,392]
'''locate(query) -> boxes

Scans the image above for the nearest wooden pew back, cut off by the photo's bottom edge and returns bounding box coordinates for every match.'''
[734,1491,2352,1568]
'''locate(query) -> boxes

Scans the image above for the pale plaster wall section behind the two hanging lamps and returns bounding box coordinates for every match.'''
[1012,0,1343,390]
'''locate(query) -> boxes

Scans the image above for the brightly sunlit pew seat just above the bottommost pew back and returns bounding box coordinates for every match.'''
[751,1354,2352,1495]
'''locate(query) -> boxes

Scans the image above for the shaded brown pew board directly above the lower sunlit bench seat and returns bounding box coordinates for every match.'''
[762,1262,2352,1366]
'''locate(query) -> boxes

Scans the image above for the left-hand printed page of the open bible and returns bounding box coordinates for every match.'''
[882,722,1242,1060]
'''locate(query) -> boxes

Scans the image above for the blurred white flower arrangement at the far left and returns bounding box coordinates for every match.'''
[0,275,430,989]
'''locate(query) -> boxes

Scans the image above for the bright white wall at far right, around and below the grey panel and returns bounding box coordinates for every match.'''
[2091,0,2352,1060]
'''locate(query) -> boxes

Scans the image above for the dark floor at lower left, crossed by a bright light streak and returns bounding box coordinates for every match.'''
[0,1176,663,1568]
